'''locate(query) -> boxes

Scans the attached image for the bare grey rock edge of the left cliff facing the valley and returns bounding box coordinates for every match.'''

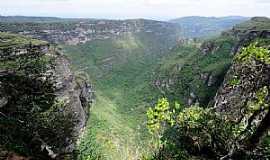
[54,55,93,153]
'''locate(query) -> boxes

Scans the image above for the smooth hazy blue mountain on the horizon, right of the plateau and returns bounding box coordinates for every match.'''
[170,16,250,38]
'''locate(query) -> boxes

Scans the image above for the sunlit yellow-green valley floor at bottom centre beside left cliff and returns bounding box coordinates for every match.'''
[89,91,151,160]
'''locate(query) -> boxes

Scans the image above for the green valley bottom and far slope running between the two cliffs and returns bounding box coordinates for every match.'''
[62,33,173,160]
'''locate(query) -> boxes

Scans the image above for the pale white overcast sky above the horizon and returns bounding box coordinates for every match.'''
[0,0,270,20]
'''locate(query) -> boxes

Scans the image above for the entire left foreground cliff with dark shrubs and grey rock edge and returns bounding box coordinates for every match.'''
[0,33,93,159]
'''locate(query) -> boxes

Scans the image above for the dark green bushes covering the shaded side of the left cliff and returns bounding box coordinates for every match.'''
[0,44,65,159]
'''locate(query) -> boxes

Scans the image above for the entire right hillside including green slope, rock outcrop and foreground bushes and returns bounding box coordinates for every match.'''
[147,17,270,160]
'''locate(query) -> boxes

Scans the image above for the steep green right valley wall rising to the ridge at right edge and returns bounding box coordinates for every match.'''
[153,17,270,106]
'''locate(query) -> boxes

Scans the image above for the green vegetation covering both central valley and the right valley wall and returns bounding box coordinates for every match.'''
[62,23,237,159]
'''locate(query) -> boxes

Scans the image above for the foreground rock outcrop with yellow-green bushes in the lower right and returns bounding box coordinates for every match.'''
[147,18,270,160]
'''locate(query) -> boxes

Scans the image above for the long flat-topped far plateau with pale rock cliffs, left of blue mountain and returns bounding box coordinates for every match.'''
[0,17,181,44]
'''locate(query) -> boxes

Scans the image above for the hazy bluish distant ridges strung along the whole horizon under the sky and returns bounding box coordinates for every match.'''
[0,16,250,41]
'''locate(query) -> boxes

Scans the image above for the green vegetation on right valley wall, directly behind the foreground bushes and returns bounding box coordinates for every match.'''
[155,36,236,106]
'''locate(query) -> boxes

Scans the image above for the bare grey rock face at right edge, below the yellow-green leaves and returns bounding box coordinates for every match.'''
[215,58,270,121]
